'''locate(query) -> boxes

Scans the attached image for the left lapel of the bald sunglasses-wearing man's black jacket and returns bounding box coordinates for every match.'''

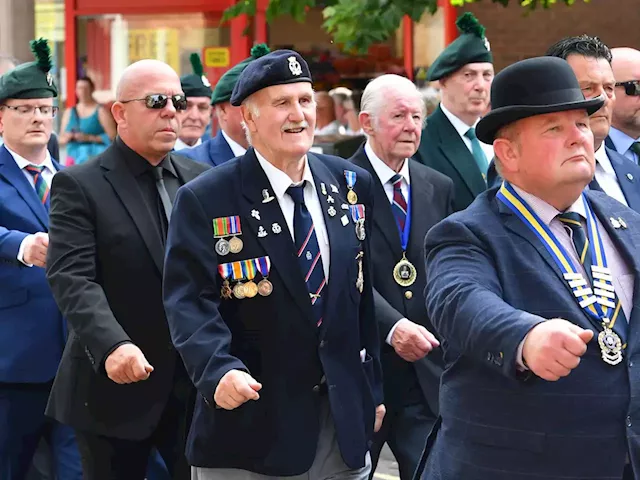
[102,143,164,273]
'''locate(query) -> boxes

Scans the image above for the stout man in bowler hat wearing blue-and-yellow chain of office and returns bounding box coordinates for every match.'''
[421,57,640,480]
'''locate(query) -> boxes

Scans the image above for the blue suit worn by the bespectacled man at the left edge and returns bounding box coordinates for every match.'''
[0,146,81,480]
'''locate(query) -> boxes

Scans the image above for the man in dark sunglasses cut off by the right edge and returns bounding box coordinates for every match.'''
[607,47,640,165]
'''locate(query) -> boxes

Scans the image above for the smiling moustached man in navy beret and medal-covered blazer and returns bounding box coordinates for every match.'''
[164,50,384,480]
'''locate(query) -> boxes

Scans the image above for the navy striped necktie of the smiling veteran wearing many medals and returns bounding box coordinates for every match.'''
[287,181,327,327]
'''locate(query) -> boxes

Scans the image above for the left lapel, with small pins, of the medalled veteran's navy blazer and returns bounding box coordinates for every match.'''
[240,148,313,318]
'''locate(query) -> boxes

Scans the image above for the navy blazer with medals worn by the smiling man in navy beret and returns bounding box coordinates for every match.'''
[164,149,382,476]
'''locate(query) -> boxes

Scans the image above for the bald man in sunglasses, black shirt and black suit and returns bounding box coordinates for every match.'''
[47,60,207,480]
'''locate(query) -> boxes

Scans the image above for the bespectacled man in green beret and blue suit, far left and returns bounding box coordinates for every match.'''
[0,39,82,480]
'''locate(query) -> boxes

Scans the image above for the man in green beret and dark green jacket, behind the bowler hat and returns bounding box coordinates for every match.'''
[415,12,494,211]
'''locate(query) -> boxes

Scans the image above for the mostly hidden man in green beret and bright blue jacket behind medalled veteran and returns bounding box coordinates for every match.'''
[176,43,269,167]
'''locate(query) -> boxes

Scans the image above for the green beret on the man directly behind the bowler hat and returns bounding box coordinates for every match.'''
[427,12,493,82]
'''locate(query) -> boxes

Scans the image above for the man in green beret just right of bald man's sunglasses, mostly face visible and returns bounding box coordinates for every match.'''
[174,53,212,151]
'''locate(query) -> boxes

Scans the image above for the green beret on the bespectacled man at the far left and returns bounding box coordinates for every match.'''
[0,38,58,101]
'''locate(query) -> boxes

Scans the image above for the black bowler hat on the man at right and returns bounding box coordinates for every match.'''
[476,57,604,143]
